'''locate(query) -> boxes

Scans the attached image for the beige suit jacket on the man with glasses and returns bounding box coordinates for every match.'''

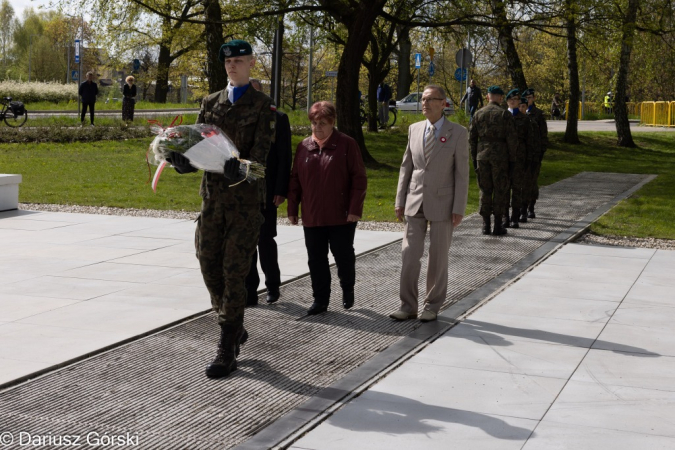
[396,118,469,221]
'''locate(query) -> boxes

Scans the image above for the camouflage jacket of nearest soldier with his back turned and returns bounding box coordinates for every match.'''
[469,102,518,162]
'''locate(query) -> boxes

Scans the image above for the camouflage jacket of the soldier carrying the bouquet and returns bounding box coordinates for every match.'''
[197,86,276,205]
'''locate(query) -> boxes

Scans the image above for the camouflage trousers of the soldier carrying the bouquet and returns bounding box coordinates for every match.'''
[195,199,263,325]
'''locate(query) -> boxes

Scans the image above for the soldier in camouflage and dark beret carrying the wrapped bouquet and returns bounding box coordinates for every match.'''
[171,40,276,378]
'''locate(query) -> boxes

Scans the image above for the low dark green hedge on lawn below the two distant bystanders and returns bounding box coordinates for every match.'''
[0,127,154,144]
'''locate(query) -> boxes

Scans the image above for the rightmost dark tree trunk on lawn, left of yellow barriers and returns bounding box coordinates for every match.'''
[614,0,640,147]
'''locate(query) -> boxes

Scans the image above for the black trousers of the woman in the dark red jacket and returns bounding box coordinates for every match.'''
[304,222,356,305]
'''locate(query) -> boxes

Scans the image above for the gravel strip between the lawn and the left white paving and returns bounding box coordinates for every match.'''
[19,203,403,232]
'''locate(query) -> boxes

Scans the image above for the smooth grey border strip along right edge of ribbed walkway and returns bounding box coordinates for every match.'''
[234,171,656,450]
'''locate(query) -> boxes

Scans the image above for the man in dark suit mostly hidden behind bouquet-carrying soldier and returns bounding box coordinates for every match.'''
[246,79,293,306]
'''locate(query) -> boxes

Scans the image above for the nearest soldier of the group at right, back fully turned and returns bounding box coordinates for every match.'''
[469,86,518,236]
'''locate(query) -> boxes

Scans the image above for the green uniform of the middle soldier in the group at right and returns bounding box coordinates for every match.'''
[505,94,538,228]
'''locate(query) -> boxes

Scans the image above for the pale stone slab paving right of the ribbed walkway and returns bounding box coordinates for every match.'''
[291,244,675,450]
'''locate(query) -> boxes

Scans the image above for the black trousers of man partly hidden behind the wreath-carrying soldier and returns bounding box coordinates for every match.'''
[246,208,281,299]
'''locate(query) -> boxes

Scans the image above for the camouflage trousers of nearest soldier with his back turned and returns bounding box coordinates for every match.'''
[478,160,509,218]
